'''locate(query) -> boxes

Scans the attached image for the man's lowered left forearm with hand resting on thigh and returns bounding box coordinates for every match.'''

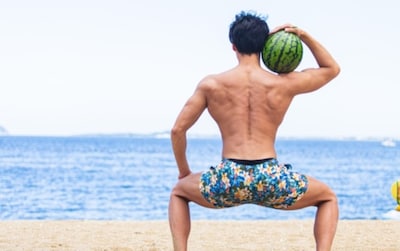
[171,130,191,178]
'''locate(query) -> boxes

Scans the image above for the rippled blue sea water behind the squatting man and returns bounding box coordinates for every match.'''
[0,136,400,220]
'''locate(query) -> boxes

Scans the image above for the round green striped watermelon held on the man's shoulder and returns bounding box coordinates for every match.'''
[262,30,303,73]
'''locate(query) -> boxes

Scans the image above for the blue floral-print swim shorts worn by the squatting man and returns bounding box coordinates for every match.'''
[199,158,308,208]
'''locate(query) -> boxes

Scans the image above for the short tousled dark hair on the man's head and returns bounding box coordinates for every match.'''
[229,11,269,54]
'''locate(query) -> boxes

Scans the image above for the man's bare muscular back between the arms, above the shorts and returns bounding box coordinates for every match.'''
[202,66,292,159]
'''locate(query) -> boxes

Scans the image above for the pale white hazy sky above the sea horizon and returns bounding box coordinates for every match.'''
[0,0,400,138]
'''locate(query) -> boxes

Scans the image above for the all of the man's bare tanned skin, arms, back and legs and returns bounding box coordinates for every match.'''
[169,24,340,250]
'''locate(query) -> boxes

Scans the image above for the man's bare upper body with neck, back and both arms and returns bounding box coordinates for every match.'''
[171,26,340,177]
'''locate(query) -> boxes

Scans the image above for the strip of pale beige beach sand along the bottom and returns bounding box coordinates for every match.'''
[0,220,400,251]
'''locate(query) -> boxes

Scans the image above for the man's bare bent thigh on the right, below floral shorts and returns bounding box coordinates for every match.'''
[286,176,336,210]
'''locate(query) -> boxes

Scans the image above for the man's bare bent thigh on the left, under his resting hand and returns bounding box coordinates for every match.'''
[174,173,214,208]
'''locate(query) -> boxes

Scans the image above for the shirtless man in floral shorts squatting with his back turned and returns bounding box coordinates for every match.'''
[169,12,340,250]
